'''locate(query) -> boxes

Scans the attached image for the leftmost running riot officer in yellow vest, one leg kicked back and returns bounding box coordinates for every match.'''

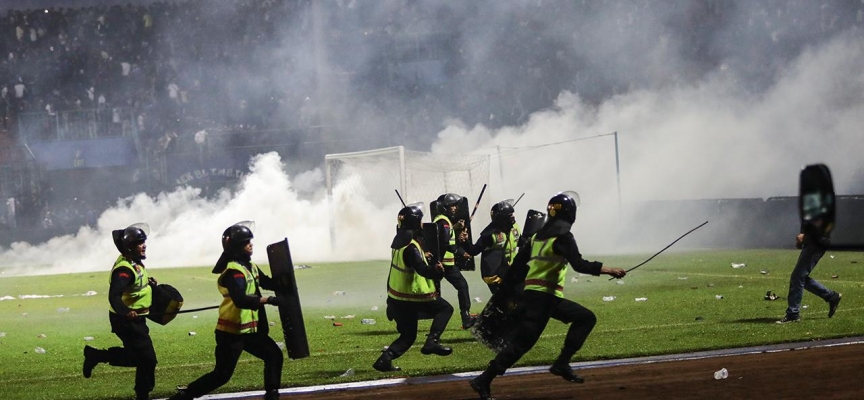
[83,223,157,400]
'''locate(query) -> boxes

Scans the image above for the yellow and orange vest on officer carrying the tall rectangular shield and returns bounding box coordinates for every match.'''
[216,261,258,334]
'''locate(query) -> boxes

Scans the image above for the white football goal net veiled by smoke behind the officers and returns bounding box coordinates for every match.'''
[324,146,491,246]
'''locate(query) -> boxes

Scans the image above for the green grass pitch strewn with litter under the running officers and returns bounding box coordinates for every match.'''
[0,250,864,399]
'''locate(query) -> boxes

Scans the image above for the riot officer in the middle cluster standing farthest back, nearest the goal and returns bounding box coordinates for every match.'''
[432,193,474,329]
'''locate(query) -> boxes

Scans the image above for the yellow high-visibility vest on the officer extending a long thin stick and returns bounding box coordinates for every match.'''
[525,235,567,298]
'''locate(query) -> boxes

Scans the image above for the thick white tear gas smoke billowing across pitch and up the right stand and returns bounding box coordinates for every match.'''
[0,1,864,273]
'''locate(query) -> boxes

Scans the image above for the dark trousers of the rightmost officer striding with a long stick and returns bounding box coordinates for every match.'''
[495,290,597,373]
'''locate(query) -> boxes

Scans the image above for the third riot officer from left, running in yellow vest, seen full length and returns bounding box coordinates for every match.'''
[372,203,453,372]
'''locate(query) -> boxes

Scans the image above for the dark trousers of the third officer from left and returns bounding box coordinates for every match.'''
[387,297,453,358]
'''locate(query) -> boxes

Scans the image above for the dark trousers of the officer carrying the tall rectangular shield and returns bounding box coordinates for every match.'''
[186,330,284,397]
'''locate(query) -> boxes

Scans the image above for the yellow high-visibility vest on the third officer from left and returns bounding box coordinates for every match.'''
[387,240,436,302]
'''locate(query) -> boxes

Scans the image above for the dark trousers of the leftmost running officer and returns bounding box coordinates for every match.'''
[105,313,157,394]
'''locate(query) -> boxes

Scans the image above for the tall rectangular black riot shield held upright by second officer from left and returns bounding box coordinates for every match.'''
[267,239,309,360]
